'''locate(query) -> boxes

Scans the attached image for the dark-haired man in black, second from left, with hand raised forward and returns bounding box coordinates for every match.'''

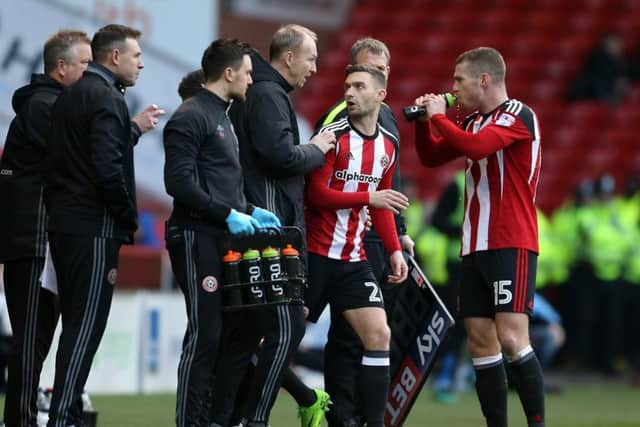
[46,25,163,427]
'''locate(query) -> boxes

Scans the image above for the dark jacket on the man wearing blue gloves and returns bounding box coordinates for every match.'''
[163,89,252,233]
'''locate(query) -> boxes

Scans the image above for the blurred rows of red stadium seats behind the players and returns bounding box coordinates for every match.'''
[296,0,640,212]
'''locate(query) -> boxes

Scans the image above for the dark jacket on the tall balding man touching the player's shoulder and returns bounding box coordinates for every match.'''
[229,54,324,229]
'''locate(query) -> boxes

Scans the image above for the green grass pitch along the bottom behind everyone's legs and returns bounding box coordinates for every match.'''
[12,384,640,427]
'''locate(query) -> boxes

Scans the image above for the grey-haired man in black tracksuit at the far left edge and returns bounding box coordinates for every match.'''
[0,29,91,426]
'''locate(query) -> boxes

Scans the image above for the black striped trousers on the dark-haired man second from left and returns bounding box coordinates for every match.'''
[47,232,121,427]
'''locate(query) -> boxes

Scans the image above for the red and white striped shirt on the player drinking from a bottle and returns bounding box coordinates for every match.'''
[416,99,541,256]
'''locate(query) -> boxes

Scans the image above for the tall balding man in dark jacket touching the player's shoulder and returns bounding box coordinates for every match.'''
[212,24,335,426]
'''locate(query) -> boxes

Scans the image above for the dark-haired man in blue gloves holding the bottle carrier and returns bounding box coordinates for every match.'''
[164,39,280,427]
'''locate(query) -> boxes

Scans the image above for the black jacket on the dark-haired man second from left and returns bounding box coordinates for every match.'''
[46,64,140,243]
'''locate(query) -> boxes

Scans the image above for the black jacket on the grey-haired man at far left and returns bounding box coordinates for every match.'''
[0,74,64,263]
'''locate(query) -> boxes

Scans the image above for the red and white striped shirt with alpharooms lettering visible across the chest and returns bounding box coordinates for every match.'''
[305,118,400,262]
